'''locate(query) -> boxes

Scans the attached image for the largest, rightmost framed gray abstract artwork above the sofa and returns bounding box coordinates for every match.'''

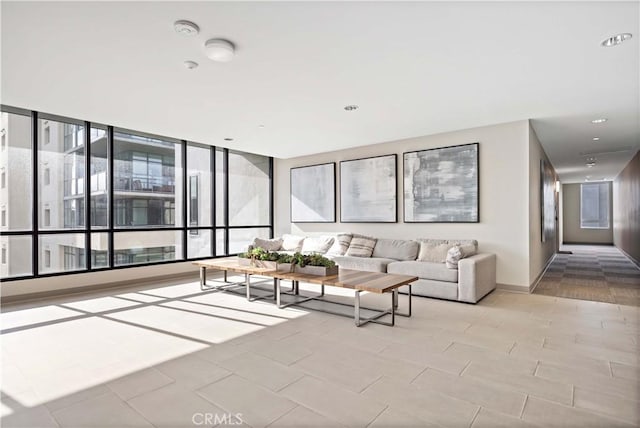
[404,143,479,223]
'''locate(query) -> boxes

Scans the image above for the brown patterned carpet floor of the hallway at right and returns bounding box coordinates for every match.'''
[534,245,640,306]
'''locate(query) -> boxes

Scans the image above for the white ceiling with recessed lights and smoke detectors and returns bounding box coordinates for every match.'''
[1,1,640,182]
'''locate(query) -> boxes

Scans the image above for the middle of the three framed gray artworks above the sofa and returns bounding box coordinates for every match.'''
[340,155,397,223]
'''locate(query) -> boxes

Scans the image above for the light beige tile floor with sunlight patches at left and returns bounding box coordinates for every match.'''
[0,281,640,428]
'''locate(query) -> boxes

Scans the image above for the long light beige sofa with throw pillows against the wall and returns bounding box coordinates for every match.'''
[253,233,496,303]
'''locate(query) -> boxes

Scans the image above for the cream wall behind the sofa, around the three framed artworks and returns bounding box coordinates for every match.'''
[274,120,530,290]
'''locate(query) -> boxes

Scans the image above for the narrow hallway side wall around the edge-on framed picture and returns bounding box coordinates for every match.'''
[529,126,559,285]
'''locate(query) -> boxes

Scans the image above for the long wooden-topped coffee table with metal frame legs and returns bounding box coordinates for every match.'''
[193,257,418,327]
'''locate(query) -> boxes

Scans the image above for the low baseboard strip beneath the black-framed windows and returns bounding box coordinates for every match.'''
[0,271,199,307]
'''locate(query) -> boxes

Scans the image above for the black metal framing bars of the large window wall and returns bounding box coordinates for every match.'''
[0,105,275,280]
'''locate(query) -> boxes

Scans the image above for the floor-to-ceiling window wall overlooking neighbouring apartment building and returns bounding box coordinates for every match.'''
[0,106,273,280]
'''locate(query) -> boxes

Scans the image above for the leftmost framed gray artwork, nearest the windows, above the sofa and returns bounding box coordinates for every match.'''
[291,163,336,223]
